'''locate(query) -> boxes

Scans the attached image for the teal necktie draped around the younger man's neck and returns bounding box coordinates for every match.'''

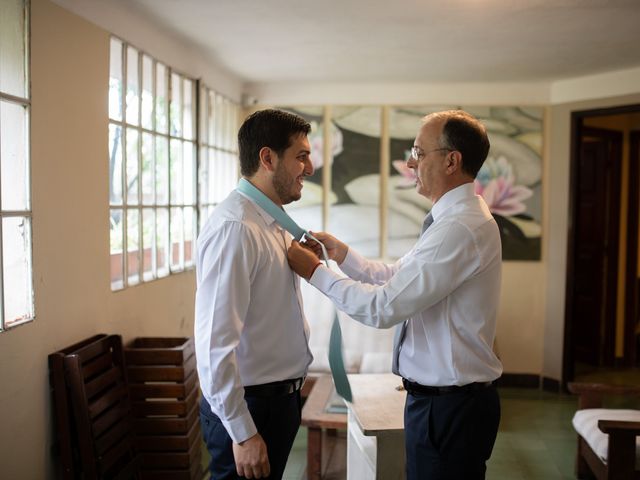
[237,178,353,402]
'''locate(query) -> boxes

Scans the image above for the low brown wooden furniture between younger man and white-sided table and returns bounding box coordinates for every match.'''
[302,375,347,480]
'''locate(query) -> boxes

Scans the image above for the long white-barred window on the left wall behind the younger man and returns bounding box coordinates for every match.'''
[109,37,239,290]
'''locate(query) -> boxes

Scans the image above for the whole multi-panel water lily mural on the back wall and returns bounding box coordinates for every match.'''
[276,106,543,260]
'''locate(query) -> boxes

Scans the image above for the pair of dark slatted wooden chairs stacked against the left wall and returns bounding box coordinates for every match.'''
[49,334,140,480]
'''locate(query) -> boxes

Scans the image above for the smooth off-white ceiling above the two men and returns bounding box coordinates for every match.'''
[121,0,640,83]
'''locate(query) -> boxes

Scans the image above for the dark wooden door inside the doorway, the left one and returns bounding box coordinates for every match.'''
[572,128,622,366]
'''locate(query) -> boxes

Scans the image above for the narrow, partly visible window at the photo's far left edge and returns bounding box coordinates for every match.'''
[0,0,35,331]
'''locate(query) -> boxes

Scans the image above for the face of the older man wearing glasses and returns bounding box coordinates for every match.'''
[407,118,451,203]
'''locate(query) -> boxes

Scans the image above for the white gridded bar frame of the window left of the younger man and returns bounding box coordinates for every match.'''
[108,35,199,291]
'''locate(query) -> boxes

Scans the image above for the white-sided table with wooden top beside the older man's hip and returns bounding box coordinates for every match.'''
[347,373,406,480]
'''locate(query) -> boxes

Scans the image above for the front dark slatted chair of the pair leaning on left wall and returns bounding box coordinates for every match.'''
[64,335,140,480]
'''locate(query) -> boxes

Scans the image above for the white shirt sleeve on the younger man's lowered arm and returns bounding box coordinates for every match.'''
[195,222,257,443]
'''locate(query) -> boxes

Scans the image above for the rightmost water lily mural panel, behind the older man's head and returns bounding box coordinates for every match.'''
[387,105,543,260]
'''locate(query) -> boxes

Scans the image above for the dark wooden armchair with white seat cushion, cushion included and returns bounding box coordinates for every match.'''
[568,383,640,480]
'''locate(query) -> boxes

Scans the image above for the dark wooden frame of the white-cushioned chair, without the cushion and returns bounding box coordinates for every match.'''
[568,383,640,480]
